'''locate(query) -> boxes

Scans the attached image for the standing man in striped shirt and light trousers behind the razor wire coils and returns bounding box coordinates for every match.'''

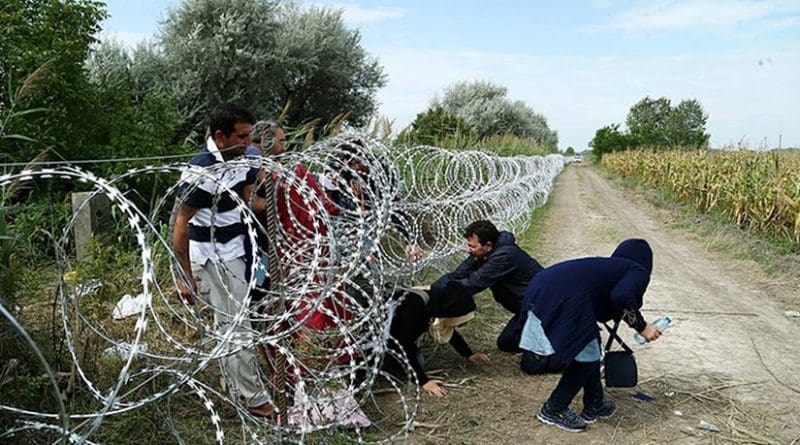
[172,103,272,417]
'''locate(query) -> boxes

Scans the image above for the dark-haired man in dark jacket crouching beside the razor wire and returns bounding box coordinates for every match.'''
[439,220,542,352]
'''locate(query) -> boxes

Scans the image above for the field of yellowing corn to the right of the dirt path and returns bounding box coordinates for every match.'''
[603,150,800,249]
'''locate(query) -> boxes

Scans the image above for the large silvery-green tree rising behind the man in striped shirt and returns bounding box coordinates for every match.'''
[145,0,386,136]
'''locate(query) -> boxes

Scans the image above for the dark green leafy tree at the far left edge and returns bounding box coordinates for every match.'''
[0,0,106,161]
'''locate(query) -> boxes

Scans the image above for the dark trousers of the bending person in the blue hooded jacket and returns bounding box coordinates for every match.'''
[547,360,604,412]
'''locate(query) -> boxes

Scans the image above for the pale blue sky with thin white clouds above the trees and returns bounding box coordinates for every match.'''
[104,0,800,150]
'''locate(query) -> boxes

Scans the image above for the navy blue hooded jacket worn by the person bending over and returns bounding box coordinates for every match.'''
[522,239,653,364]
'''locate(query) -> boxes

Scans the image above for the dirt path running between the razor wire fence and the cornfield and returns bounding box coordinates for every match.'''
[412,165,800,444]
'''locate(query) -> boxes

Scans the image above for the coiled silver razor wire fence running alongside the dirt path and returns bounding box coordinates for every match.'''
[0,130,564,444]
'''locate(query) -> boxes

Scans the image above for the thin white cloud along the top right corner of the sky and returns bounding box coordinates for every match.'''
[595,0,800,33]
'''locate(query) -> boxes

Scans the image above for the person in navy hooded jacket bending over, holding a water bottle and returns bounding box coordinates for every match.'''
[519,239,661,432]
